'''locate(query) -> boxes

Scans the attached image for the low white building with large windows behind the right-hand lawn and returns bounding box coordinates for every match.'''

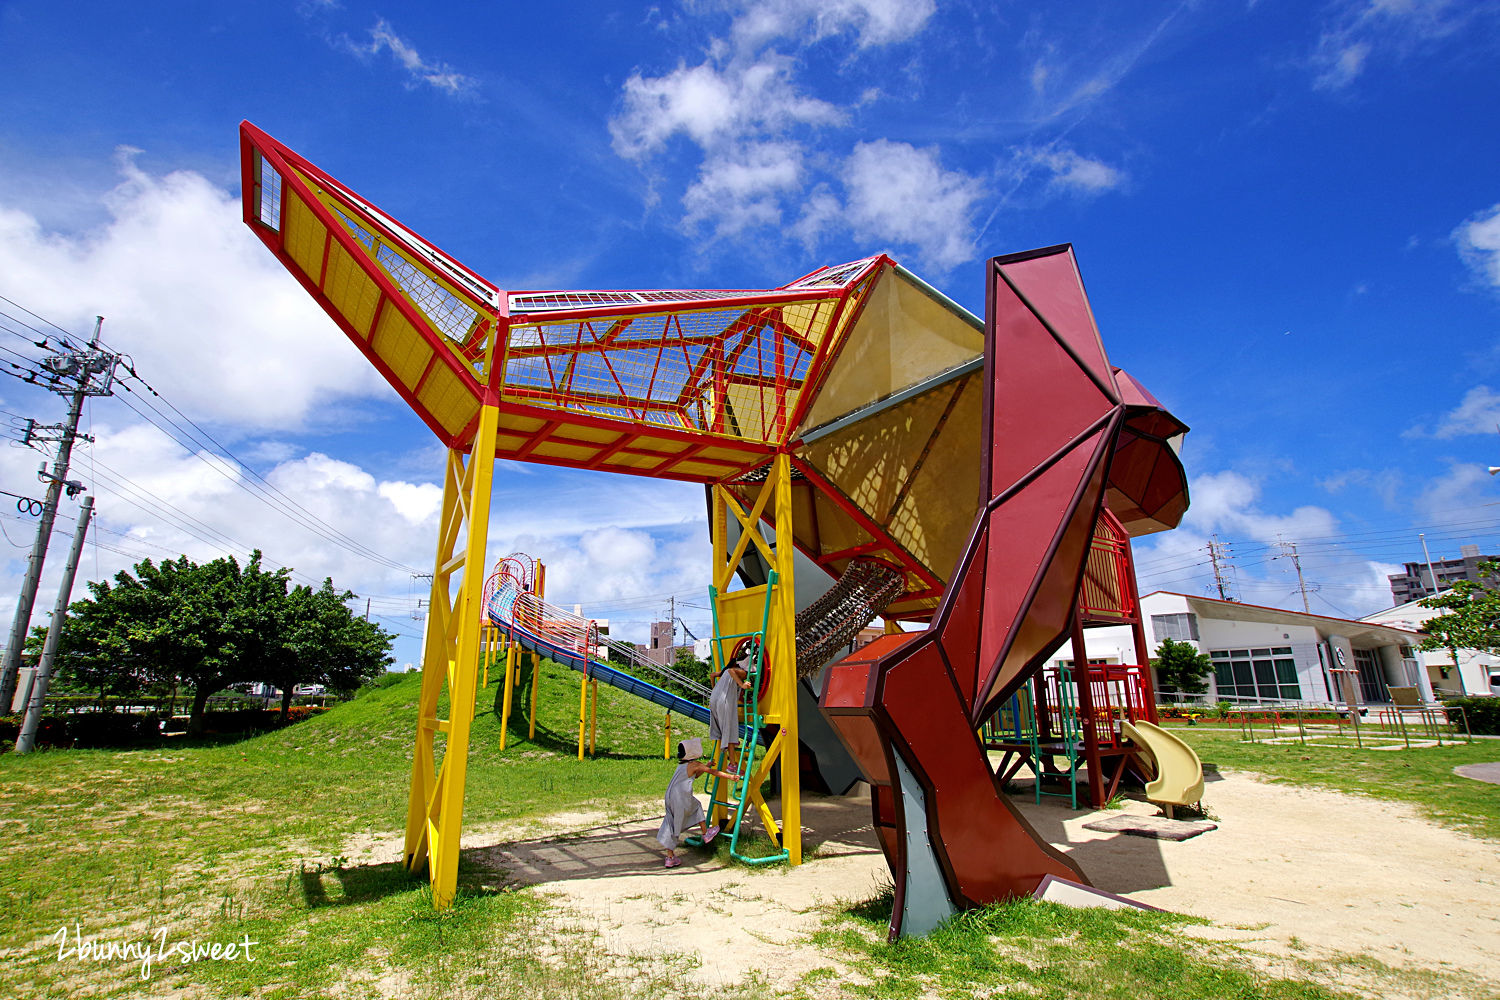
[1080,591,1433,705]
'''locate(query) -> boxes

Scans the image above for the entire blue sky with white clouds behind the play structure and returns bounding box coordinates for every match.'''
[0,0,1500,663]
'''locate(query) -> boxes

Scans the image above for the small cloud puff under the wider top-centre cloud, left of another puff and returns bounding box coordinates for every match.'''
[683,142,803,237]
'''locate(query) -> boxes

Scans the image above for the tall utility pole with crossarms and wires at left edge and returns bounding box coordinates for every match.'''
[0,316,120,709]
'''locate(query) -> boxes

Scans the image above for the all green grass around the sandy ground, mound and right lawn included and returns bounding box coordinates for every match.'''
[0,664,1500,1000]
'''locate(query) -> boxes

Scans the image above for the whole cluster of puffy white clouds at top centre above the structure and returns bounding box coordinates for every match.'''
[609,0,960,270]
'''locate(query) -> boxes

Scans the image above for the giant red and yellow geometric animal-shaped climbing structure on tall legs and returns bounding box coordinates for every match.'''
[240,123,1187,934]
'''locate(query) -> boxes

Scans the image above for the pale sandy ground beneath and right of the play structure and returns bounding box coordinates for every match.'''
[345,774,1500,984]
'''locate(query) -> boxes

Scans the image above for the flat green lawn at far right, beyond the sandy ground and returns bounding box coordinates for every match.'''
[1172,727,1500,840]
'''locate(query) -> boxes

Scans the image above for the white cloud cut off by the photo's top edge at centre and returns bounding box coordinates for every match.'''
[731,0,938,48]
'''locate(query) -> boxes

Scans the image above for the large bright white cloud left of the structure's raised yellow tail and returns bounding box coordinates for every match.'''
[0,151,395,429]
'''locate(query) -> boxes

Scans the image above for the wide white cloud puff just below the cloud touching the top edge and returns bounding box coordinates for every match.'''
[609,54,845,159]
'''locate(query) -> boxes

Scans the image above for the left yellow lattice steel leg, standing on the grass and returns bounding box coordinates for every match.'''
[404,405,500,909]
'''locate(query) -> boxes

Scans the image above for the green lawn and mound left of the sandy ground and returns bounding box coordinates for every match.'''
[0,663,704,997]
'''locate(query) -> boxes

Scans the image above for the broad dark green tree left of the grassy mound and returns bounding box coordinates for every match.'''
[41,550,393,732]
